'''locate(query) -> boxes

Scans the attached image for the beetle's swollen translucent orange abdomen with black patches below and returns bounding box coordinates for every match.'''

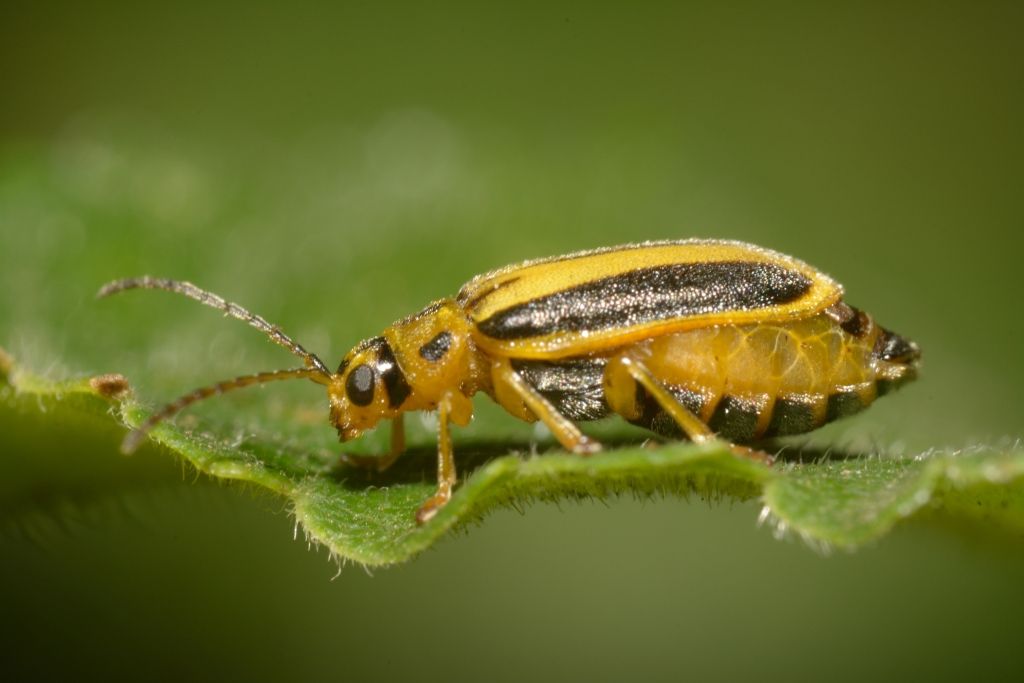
[622,313,879,441]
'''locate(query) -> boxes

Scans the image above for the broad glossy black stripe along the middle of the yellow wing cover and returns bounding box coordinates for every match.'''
[477,261,811,339]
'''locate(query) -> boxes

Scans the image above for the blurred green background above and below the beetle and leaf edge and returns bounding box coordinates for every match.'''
[0,2,1024,680]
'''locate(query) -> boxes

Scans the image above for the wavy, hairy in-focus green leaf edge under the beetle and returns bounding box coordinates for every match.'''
[5,352,1024,566]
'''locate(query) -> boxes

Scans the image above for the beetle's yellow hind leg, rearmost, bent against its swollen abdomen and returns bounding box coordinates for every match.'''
[604,355,774,464]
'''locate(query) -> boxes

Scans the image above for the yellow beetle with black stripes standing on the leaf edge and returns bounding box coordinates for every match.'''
[97,240,921,523]
